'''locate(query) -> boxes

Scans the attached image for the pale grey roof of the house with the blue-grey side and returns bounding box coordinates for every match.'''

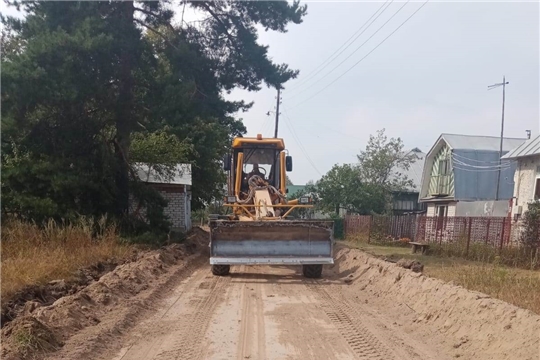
[441,134,527,152]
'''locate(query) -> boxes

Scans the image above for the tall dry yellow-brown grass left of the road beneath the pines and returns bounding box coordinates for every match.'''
[1,218,131,301]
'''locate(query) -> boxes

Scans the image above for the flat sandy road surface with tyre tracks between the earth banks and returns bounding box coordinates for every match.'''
[105,264,450,360]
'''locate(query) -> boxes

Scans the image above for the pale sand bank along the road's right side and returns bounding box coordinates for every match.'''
[329,248,540,360]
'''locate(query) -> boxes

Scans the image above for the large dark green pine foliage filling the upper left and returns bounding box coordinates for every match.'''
[1,1,306,233]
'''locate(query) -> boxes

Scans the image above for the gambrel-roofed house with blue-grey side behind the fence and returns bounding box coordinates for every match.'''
[420,134,526,217]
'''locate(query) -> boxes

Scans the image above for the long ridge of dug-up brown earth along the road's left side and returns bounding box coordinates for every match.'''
[2,228,208,359]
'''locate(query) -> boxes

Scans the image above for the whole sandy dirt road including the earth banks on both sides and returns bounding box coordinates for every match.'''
[6,229,540,360]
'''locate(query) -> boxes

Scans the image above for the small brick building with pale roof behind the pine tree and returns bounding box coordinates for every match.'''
[132,163,191,232]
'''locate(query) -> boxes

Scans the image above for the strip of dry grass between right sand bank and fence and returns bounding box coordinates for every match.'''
[344,242,540,314]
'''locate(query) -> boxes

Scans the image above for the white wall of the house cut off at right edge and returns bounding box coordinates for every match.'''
[512,156,540,216]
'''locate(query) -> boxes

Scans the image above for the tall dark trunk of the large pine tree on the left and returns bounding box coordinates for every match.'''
[115,1,137,217]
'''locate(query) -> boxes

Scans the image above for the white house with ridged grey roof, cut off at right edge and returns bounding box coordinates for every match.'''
[502,135,540,220]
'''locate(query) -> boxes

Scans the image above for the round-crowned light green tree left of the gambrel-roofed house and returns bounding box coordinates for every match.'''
[358,129,416,191]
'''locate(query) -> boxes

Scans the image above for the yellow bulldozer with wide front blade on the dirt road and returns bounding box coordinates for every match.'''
[209,135,334,278]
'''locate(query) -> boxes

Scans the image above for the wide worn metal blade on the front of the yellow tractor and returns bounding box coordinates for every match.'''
[209,220,334,265]
